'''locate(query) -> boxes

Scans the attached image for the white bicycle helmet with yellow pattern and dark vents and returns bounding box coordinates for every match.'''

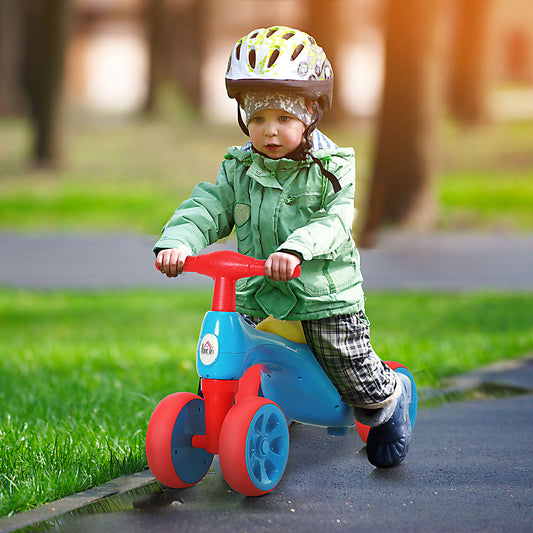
[226,26,333,111]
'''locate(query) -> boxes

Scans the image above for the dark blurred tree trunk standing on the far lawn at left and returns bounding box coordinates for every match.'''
[25,0,70,167]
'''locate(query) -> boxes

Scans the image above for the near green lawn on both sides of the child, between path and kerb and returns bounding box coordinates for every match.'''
[0,289,533,516]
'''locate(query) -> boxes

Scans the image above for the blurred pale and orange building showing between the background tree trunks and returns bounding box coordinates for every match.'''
[66,0,533,120]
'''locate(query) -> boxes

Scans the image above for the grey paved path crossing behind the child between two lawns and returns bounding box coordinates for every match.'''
[0,233,533,290]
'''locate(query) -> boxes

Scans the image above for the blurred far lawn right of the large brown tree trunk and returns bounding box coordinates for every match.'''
[438,121,533,231]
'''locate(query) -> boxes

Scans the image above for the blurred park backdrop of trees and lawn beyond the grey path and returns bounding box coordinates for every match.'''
[0,0,533,246]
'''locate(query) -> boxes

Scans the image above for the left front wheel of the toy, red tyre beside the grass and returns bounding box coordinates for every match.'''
[146,392,213,488]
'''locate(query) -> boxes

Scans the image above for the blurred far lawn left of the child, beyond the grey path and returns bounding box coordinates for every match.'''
[0,113,235,234]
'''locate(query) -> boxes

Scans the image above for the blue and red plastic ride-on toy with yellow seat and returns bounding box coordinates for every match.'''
[146,251,417,496]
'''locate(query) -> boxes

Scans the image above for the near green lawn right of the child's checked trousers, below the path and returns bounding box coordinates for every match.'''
[366,292,533,387]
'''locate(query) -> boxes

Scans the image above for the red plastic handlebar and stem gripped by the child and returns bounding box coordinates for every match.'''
[160,250,301,311]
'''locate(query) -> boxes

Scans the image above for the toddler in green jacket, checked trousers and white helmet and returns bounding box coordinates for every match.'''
[154,26,411,467]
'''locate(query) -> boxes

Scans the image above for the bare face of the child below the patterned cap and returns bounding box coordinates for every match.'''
[248,109,305,159]
